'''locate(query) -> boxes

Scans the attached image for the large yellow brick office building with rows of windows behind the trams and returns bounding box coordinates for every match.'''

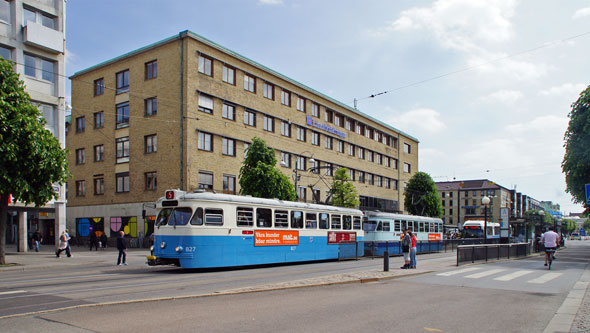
[66,31,418,237]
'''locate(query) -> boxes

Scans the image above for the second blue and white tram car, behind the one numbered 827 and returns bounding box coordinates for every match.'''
[363,212,443,256]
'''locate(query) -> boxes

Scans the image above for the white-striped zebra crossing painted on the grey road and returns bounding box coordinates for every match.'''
[436,267,563,284]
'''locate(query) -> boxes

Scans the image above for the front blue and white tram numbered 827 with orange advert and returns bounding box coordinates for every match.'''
[148,190,364,268]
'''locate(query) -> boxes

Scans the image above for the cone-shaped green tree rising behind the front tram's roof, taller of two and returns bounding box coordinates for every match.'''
[240,137,297,201]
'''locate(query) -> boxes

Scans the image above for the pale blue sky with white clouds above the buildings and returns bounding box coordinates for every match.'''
[66,0,590,214]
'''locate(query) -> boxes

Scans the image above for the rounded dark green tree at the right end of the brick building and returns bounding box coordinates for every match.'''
[404,171,443,217]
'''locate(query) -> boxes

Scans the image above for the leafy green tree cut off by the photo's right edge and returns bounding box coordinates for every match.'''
[561,86,590,212]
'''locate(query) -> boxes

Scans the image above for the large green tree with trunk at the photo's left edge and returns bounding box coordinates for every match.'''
[0,58,70,264]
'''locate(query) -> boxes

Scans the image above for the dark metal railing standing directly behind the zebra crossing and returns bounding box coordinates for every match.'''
[457,243,531,266]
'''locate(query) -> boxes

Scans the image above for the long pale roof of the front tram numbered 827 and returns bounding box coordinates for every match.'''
[158,190,363,215]
